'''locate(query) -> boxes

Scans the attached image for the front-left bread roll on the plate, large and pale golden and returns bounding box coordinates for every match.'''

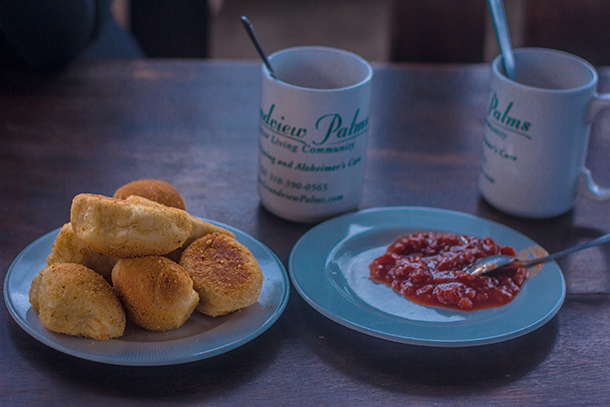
[30,263,125,340]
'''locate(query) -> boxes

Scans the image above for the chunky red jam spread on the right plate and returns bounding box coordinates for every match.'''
[369,232,527,310]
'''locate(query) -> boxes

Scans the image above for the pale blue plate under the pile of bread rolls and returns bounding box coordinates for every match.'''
[4,221,290,366]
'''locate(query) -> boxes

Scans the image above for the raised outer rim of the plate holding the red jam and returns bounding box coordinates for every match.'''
[288,206,567,348]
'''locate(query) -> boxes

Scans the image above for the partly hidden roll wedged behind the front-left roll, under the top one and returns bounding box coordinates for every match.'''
[47,223,117,282]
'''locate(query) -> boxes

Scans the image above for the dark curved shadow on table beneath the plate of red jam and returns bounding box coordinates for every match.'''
[301,308,558,396]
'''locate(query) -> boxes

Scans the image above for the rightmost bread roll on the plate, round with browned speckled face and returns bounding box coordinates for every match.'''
[180,233,263,317]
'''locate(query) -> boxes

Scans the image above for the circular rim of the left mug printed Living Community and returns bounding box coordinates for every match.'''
[262,46,373,93]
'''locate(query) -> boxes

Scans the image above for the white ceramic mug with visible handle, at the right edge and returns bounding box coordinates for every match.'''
[479,48,610,218]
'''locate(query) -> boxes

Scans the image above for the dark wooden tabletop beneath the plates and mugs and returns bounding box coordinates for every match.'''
[0,61,610,406]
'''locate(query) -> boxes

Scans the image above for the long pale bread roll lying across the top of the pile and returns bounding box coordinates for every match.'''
[70,194,193,258]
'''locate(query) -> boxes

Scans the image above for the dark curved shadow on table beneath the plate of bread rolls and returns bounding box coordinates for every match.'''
[8,310,286,403]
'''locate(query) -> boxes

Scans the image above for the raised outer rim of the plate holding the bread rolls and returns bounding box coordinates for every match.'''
[3,222,290,366]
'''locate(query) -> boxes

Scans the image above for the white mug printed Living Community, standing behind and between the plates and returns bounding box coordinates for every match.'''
[258,47,373,222]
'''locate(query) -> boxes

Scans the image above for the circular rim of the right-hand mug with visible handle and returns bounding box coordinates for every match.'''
[491,47,598,93]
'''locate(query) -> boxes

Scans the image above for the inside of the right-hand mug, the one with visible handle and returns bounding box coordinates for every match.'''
[492,48,597,90]
